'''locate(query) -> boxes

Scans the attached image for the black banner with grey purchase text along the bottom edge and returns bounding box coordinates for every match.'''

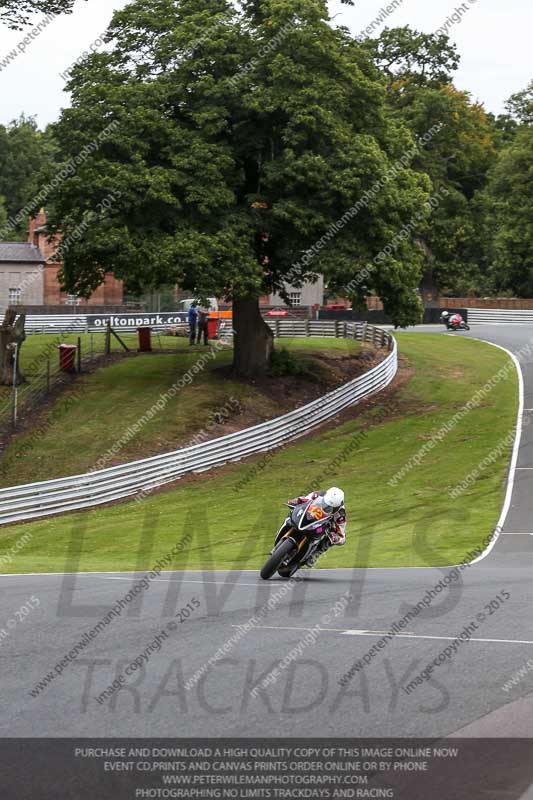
[0,738,533,800]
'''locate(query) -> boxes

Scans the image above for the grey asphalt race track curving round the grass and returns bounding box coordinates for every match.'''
[0,325,533,756]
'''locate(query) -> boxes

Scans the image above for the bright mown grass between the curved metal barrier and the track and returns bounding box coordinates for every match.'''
[0,334,518,572]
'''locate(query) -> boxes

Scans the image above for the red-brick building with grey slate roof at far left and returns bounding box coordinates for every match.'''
[0,209,124,311]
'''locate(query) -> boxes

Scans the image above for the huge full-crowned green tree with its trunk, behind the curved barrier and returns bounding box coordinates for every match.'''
[44,0,430,375]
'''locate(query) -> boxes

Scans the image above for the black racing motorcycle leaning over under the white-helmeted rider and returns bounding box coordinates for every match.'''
[261,497,334,581]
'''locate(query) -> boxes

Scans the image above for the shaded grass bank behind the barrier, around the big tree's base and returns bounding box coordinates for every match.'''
[0,337,362,486]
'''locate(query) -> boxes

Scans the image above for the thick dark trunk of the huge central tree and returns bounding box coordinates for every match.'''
[233,298,274,378]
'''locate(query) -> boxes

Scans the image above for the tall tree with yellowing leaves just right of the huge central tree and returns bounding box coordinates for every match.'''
[366,27,496,294]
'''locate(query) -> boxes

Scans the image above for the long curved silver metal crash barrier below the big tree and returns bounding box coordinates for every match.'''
[0,322,398,525]
